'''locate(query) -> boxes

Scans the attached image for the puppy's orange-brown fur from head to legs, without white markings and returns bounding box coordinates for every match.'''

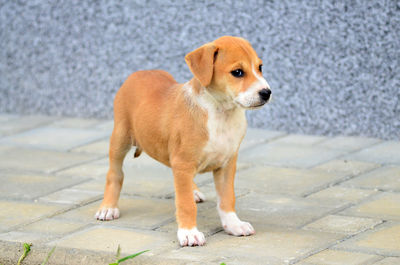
[95,37,270,245]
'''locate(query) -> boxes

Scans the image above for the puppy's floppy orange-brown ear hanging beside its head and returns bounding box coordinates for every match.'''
[185,43,218,87]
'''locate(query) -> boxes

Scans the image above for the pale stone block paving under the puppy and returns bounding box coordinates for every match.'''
[0,114,400,265]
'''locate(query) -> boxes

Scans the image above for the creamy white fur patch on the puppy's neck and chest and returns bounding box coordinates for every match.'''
[186,85,247,172]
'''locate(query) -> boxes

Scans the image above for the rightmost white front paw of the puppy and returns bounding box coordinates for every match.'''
[220,211,256,236]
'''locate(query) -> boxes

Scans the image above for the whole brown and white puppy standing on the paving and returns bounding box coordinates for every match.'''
[96,36,271,246]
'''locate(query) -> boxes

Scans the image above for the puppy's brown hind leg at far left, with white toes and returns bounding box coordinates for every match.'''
[95,124,133,221]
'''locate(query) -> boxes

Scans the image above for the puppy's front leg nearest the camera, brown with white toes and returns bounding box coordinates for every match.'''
[172,161,206,246]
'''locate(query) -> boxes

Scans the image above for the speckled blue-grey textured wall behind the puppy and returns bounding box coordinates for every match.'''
[0,0,400,139]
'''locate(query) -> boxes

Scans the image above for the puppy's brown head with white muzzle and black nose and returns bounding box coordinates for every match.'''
[185,36,271,109]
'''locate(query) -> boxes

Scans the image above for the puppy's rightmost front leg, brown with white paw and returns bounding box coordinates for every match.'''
[213,154,255,236]
